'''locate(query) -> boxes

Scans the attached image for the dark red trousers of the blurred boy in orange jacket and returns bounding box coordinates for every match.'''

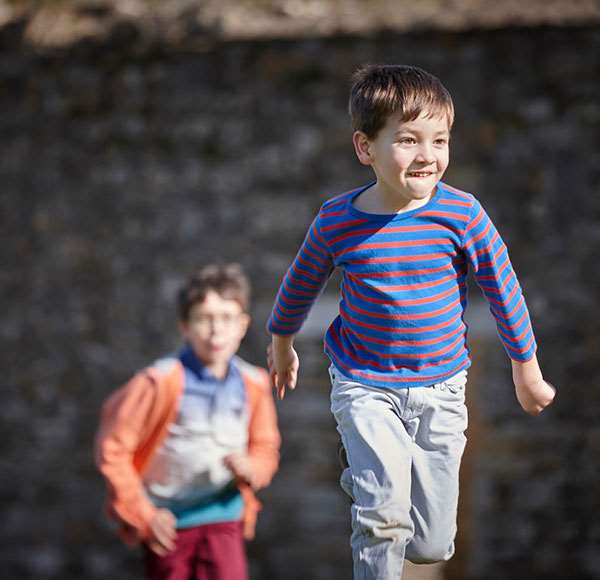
[145,522,248,580]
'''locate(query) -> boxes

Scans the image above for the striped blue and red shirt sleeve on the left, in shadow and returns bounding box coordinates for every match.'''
[267,211,334,335]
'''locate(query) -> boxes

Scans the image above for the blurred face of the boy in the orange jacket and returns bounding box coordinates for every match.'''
[180,290,250,371]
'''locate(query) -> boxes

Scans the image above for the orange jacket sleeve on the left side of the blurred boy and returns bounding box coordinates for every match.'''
[95,372,157,543]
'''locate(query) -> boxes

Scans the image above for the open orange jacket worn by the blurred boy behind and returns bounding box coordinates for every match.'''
[95,357,281,544]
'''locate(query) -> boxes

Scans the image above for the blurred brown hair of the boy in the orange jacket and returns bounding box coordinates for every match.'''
[177,264,250,322]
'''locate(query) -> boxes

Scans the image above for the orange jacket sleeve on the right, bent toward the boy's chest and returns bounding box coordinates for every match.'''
[248,369,281,489]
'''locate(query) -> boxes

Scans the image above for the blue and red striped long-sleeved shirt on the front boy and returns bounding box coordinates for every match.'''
[267,182,536,388]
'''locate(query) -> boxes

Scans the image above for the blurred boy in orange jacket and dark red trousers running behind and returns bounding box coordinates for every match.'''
[96,264,280,580]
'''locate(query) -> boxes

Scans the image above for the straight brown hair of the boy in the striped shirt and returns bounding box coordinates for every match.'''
[349,65,454,139]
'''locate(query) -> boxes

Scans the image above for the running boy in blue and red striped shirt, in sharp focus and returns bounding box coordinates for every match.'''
[268,66,554,580]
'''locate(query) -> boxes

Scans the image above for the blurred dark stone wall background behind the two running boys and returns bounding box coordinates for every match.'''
[0,0,600,580]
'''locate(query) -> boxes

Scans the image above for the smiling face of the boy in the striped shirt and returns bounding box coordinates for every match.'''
[354,112,450,206]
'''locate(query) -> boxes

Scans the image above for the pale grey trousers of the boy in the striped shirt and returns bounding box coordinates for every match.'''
[329,366,467,580]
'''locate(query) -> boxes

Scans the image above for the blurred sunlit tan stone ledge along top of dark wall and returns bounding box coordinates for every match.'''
[0,0,600,49]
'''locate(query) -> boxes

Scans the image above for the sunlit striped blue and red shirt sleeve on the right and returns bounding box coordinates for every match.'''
[463,200,537,362]
